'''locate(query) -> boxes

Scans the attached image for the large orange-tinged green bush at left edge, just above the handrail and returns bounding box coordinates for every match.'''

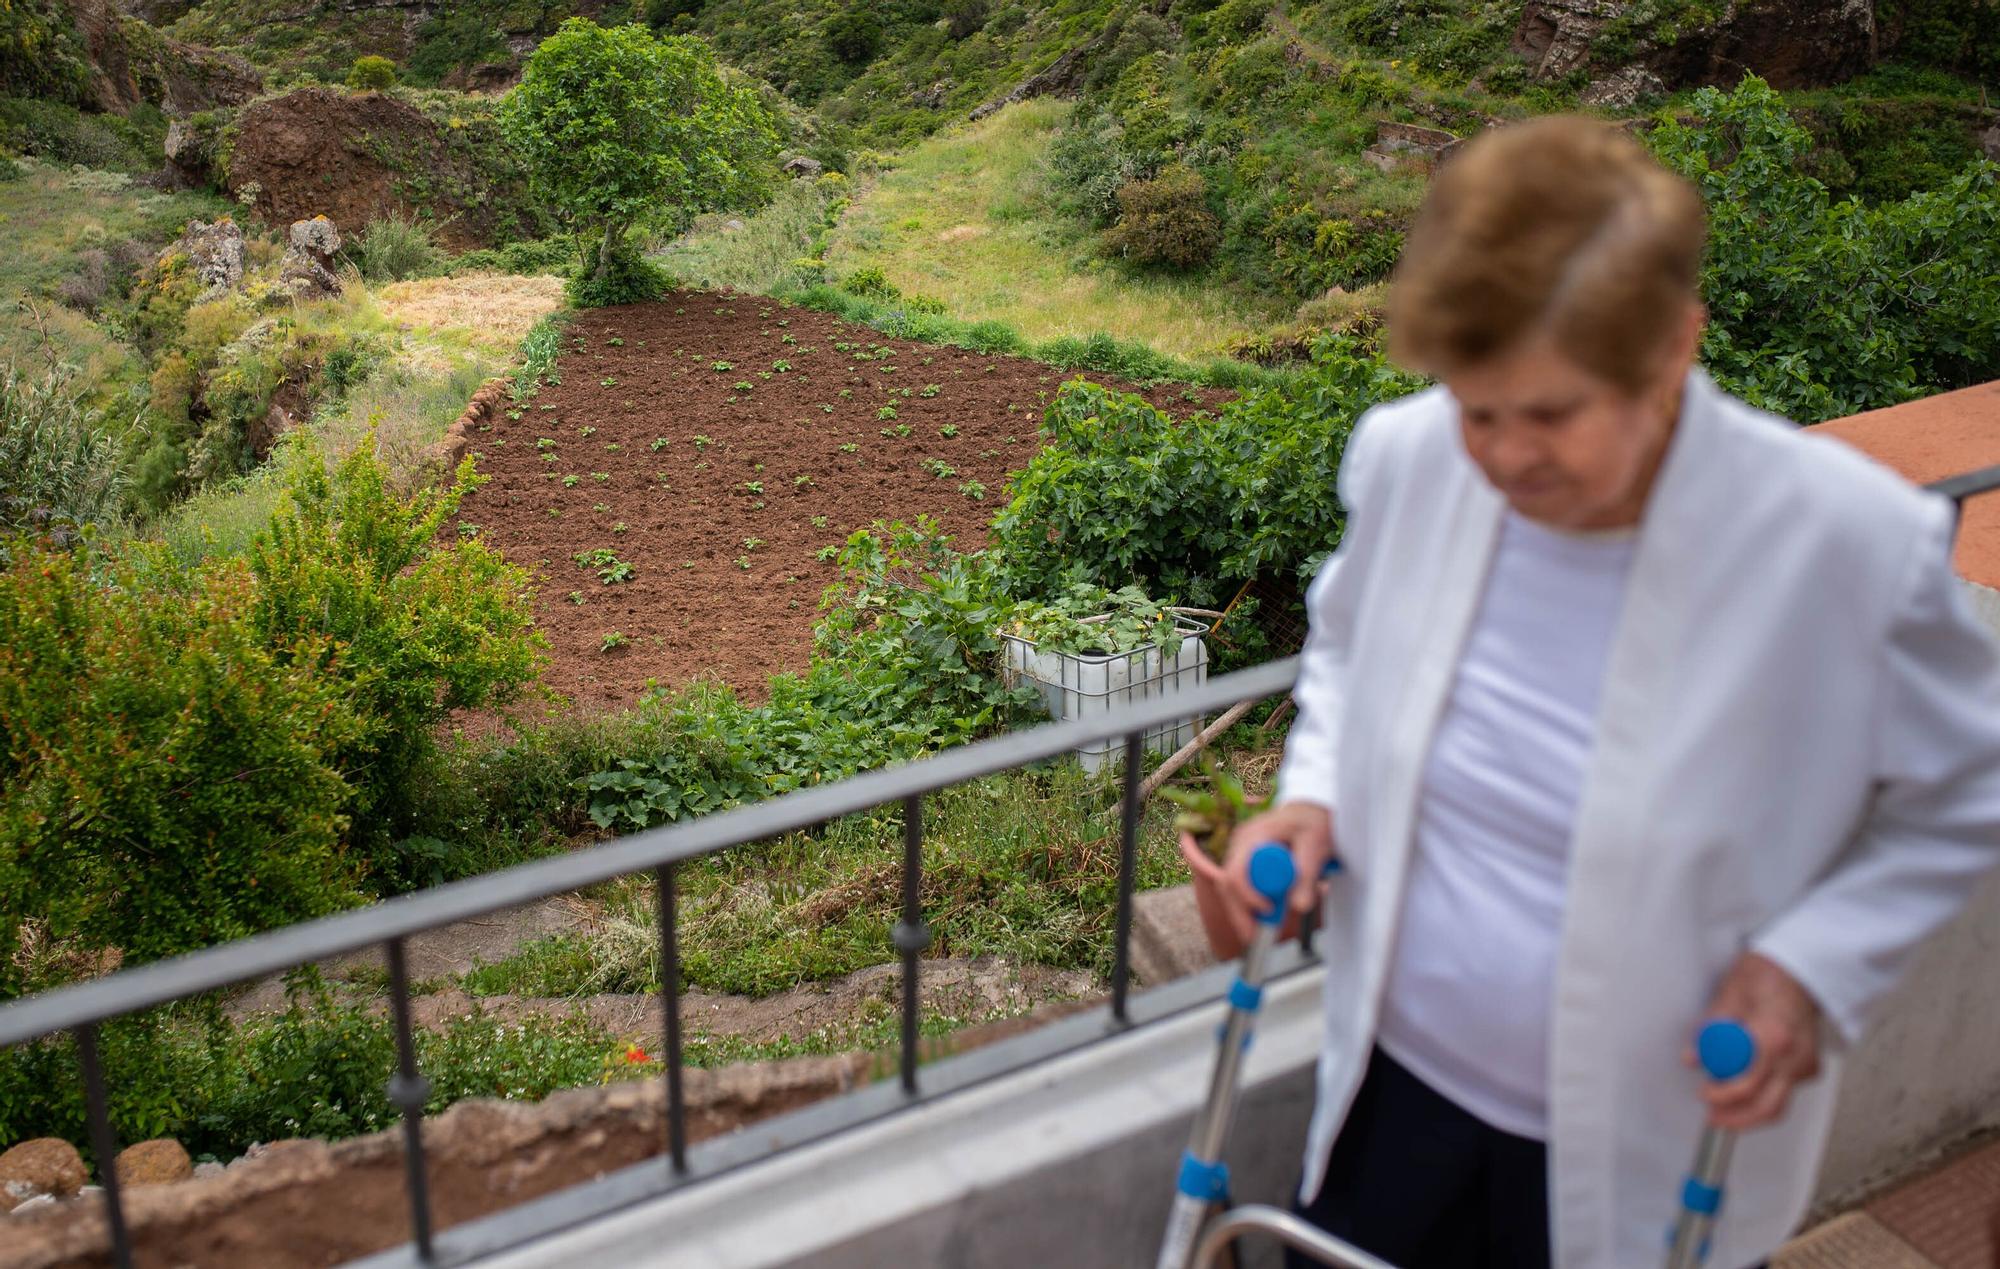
[0,542,362,995]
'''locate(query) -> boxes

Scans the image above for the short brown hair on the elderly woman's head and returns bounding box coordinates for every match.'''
[1388,114,1706,388]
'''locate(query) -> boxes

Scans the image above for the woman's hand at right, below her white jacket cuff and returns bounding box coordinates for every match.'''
[1684,953,1820,1131]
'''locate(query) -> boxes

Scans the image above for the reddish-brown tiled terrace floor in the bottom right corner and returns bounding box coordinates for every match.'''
[1772,1139,2000,1269]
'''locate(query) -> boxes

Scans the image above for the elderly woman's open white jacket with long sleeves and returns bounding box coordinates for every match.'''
[1280,372,2000,1269]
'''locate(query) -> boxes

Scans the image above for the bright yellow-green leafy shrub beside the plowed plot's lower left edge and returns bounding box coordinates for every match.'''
[250,434,546,864]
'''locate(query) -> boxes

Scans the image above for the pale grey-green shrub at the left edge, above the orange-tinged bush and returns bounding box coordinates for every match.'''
[0,366,130,530]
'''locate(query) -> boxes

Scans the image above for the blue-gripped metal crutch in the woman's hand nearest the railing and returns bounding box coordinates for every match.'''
[1156,843,1298,1269]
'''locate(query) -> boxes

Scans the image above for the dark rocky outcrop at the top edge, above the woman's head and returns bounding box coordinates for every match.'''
[1514,0,1876,91]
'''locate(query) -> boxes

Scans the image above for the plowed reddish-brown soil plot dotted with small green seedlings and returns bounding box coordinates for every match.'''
[462,294,1230,709]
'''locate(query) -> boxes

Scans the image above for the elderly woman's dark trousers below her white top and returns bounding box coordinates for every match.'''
[1284,1049,1548,1269]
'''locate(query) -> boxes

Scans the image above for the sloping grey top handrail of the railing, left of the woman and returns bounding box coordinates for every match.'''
[0,657,1298,1047]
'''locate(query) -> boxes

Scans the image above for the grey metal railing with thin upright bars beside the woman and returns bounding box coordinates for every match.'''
[0,466,2000,1269]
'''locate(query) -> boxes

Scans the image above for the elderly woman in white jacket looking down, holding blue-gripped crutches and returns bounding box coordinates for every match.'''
[1228,118,2000,1269]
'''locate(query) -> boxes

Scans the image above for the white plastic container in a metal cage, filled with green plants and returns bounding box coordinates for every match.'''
[1000,616,1208,775]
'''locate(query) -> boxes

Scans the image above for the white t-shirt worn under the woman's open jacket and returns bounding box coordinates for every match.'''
[1376,512,1636,1139]
